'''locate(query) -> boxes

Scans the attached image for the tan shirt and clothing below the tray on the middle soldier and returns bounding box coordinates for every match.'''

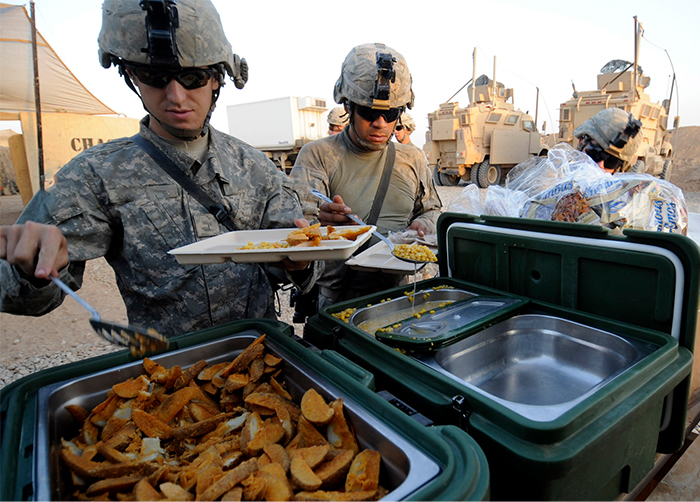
[290,128,442,300]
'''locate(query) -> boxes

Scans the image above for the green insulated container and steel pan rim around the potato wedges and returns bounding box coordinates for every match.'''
[0,320,489,500]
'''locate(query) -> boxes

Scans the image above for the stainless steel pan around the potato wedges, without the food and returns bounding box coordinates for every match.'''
[33,329,440,500]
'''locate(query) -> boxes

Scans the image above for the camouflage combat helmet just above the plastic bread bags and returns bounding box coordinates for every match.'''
[574,108,643,171]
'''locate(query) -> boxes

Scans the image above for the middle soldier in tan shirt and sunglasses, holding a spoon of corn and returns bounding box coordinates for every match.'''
[290,44,442,307]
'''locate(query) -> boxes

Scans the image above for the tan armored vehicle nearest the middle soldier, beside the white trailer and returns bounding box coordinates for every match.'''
[423,51,547,188]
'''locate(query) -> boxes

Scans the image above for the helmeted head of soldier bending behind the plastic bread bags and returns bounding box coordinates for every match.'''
[574,108,642,174]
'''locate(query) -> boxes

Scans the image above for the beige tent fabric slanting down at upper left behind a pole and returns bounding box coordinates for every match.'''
[0,3,117,120]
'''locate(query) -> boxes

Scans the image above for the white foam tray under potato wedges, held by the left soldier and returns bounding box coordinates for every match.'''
[168,226,377,265]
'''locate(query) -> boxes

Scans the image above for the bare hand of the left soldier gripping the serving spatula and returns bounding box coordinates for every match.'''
[0,221,68,279]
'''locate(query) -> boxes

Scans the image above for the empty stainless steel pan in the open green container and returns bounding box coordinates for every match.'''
[413,314,659,422]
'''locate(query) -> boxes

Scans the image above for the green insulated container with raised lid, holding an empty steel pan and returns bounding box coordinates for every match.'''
[304,213,700,500]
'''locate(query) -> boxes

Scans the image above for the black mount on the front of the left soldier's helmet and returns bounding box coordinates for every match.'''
[139,0,180,66]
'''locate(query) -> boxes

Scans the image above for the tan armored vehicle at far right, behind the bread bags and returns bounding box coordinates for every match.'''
[557,17,678,179]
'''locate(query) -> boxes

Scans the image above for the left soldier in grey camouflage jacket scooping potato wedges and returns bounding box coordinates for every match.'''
[0,0,315,336]
